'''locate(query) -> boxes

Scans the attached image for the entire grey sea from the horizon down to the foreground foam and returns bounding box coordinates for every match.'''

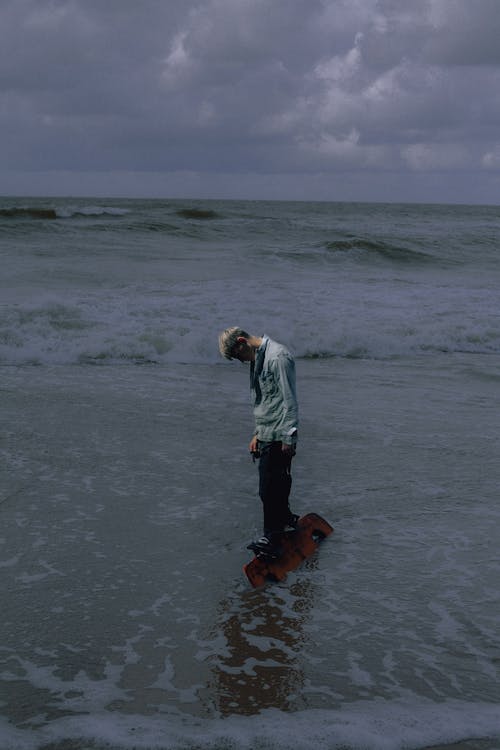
[0,198,500,750]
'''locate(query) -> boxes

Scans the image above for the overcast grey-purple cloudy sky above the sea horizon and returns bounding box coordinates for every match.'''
[0,0,500,203]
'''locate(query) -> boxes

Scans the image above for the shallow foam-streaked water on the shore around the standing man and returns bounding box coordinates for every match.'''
[0,355,500,748]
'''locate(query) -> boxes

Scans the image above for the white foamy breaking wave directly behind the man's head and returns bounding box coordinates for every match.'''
[0,288,500,365]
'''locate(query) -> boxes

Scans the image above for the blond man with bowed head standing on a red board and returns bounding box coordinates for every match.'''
[219,327,298,556]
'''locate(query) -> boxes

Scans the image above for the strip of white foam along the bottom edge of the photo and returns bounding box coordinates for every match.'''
[0,701,500,750]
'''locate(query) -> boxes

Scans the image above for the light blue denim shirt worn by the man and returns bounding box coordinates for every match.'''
[250,336,299,445]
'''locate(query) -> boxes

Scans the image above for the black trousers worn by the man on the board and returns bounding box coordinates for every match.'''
[259,443,292,535]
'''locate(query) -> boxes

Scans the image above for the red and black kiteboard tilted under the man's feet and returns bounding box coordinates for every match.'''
[243,513,333,588]
